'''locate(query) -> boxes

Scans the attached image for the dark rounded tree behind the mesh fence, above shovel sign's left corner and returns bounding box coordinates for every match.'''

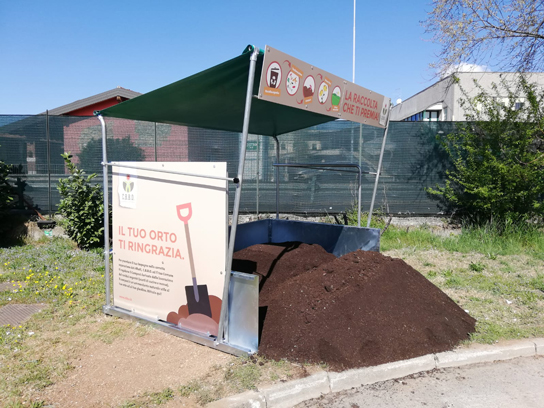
[78,136,145,173]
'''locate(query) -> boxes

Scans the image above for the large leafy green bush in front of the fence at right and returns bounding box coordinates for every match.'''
[427,75,544,224]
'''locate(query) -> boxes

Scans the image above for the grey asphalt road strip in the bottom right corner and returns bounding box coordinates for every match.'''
[297,356,544,408]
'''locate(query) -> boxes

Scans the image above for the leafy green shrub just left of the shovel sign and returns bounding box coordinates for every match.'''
[58,153,111,249]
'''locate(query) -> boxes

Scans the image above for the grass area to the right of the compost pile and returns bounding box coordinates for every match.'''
[381,225,544,343]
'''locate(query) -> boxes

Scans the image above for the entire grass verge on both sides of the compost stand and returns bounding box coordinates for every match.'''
[0,225,544,407]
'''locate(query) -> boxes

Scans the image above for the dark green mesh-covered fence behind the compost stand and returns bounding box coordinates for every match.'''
[0,115,455,214]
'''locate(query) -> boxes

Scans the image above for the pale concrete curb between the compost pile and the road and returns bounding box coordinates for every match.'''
[207,338,544,408]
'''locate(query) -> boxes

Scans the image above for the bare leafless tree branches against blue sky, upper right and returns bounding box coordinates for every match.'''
[422,0,544,75]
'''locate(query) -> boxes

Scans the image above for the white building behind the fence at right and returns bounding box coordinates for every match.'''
[391,72,544,122]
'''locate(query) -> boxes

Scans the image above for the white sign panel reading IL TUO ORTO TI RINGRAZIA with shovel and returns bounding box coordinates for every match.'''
[112,162,228,335]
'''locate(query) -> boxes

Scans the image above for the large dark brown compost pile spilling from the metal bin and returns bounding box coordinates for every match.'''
[233,242,476,370]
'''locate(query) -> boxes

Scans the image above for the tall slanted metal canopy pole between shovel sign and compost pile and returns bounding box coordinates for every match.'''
[217,47,259,343]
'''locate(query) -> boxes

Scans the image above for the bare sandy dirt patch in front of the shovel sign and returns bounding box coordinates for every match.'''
[39,330,234,407]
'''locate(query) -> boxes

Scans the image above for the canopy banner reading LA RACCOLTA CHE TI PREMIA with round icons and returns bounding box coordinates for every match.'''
[258,46,391,128]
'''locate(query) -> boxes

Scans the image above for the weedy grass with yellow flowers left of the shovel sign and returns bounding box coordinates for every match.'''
[0,238,105,406]
